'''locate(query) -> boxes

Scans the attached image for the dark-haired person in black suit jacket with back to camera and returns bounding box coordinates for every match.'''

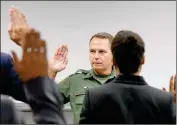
[79,30,176,124]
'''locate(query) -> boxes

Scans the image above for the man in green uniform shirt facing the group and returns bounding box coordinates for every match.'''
[51,32,115,124]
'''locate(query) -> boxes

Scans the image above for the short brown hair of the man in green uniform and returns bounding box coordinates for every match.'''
[90,32,113,44]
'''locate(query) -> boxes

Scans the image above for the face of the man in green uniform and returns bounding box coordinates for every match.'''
[89,37,113,73]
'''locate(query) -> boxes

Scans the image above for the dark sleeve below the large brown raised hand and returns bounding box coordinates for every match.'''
[24,77,66,124]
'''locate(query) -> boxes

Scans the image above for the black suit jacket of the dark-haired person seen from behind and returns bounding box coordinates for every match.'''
[80,75,176,124]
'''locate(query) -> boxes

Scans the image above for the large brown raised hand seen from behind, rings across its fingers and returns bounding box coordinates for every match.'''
[12,29,48,81]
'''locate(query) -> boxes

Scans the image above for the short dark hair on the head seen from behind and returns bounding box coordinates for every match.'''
[111,30,145,74]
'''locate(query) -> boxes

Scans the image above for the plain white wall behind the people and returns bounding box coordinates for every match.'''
[1,1,176,88]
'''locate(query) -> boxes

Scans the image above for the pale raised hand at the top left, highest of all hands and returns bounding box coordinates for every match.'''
[8,7,30,46]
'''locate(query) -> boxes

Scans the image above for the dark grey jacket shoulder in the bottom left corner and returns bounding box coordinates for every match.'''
[0,95,24,124]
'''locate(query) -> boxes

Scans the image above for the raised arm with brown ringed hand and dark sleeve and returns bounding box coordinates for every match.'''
[12,29,66,124]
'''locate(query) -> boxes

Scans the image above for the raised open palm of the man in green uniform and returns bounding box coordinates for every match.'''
[49,45,68,79]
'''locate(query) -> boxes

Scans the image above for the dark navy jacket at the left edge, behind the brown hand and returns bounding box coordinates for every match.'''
[0,52,26,102]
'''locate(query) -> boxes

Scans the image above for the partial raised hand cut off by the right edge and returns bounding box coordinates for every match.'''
[163,74,176,103]
